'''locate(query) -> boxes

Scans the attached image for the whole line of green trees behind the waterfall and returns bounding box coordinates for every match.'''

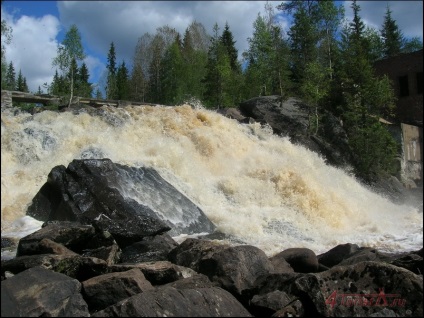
[2,0,422,179]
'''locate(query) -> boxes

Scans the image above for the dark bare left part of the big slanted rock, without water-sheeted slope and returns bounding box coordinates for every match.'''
[27,159,170,245]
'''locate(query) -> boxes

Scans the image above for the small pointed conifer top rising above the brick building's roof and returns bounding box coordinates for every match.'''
[380,4,404,57]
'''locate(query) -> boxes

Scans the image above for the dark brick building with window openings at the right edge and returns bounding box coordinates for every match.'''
[374,50,423,127]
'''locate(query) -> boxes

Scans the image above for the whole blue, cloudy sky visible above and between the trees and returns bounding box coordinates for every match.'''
[1,1,423,95]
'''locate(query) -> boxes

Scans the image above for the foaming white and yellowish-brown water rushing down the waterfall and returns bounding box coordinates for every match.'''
[1,106,423,256]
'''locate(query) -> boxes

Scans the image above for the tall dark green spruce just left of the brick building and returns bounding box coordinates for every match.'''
[333,1,396,181]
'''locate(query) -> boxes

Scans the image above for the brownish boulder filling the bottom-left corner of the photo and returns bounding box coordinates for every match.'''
[1,267,90,317]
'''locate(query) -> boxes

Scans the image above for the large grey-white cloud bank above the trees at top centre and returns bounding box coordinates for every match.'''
[58,1,281,64]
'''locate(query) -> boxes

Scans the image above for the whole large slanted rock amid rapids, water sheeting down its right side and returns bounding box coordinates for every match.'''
[27,159,214,246]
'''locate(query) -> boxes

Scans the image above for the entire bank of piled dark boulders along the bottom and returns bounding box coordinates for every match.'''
[1,221,423,317]
